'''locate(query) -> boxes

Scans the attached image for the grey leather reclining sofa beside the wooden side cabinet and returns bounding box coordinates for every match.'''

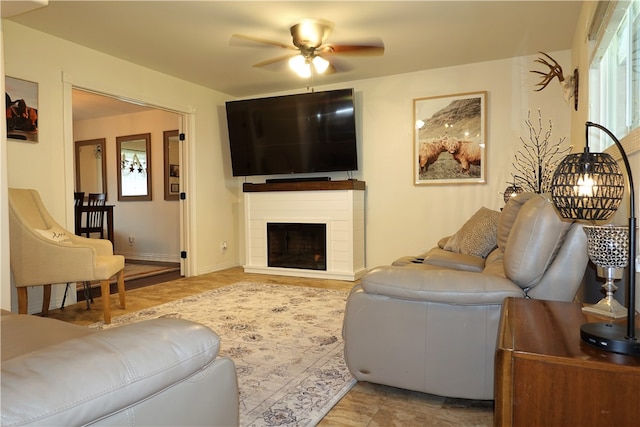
[343,194,588,399]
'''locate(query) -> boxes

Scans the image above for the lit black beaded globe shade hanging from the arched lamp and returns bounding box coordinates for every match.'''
[551,148,624,221]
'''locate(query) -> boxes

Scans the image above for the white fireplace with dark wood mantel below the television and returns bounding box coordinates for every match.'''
[242,180,366,280]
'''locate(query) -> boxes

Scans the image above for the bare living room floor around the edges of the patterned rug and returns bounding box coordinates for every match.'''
[49,267,493,427]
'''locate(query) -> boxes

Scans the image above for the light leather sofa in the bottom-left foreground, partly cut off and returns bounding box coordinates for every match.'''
[0,310,239,427]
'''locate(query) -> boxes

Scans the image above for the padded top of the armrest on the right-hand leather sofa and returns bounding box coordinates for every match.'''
[361,266,525,305]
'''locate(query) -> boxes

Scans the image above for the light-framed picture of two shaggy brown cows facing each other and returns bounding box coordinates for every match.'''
[413,92,487,185]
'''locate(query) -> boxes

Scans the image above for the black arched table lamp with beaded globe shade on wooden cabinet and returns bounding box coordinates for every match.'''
[551,122,640,356]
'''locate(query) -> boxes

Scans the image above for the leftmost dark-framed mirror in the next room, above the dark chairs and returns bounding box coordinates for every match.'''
[75,138,107,194]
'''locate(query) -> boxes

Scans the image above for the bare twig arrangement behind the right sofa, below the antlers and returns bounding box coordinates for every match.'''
[511,110,571,193]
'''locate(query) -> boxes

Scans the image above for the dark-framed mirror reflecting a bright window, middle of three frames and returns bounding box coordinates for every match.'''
[116,133,151,201]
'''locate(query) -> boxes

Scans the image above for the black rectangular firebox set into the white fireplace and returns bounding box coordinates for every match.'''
[267,222,327,271]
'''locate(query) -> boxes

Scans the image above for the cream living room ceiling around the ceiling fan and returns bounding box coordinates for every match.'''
[2,0,582,117]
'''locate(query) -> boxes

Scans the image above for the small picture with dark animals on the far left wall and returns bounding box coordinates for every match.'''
[4,76,38,142]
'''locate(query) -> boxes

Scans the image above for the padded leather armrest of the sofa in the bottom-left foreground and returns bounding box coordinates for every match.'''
[1,319,220,426]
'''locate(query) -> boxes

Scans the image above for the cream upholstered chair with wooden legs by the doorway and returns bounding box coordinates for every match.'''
[9,188,125,323]
